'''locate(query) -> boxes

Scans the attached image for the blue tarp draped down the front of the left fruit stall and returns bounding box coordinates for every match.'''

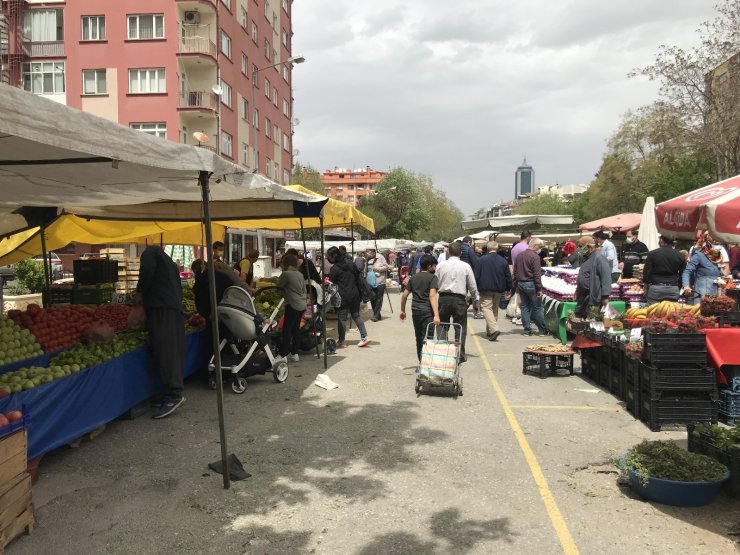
[0,332,204,459]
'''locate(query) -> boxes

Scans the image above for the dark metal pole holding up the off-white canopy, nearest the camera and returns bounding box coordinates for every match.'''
[198,171,231,489]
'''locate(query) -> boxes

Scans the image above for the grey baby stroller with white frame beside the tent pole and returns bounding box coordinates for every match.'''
[208,286,288,393]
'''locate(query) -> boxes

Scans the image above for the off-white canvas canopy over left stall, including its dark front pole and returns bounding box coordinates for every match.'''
[0,84,327,488]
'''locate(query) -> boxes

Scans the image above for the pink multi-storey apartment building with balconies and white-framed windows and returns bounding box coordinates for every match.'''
[0,0,302,264]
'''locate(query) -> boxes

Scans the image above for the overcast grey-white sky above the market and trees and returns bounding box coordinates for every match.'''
[293,0,714,215]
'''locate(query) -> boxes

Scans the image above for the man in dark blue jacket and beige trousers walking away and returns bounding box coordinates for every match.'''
[473,241,514,341]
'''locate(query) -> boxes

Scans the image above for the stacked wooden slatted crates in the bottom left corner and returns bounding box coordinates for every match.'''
[0,428,33,553]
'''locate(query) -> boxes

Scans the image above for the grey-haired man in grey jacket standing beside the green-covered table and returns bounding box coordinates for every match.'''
[576,235,612,318]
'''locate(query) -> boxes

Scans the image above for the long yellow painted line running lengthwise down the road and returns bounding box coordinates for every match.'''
[468,322,579,555]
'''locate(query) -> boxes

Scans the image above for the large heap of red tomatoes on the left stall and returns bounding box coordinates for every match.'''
[8,304,97,352]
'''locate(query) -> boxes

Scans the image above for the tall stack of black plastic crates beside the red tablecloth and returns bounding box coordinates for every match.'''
[639,332,718,431]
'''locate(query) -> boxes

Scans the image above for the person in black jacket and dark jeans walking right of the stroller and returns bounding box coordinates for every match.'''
[326,247,370,349]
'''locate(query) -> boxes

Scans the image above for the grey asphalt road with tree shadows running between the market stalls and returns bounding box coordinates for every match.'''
[8,294,740,555]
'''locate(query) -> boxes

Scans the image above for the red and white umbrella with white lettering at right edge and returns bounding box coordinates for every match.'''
[655,175,740,243]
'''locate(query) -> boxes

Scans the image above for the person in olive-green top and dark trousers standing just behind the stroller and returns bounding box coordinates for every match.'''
[277,254,306,362]
